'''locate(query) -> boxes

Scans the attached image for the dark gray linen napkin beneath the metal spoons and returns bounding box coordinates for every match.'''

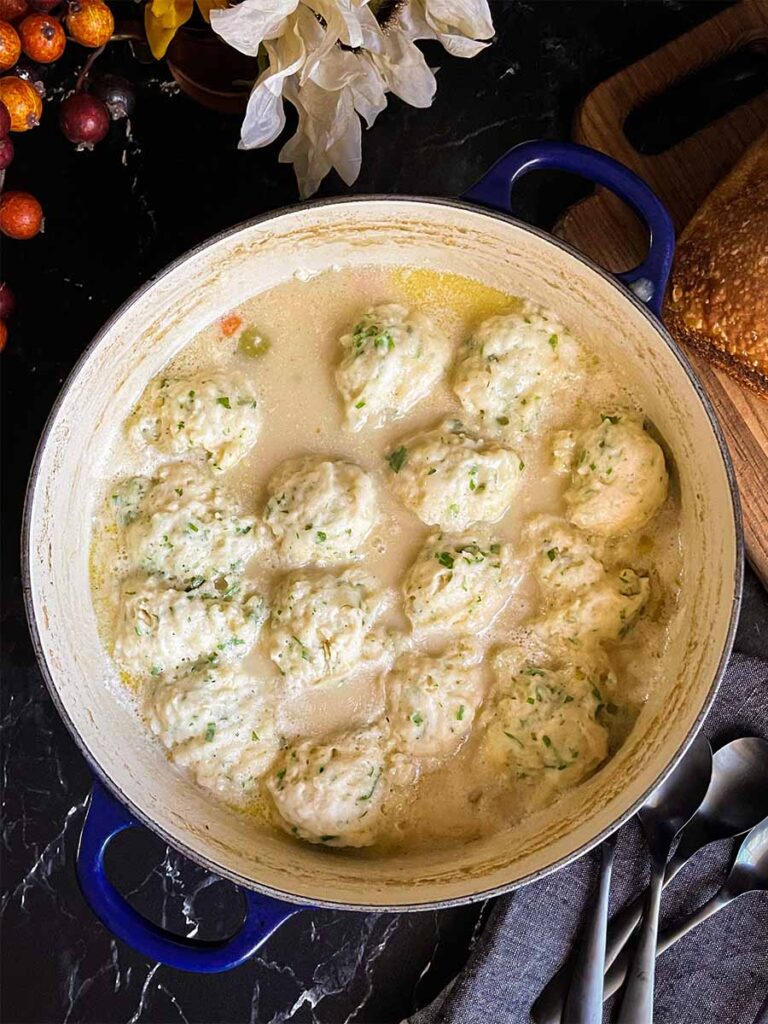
[410,654,768,1024]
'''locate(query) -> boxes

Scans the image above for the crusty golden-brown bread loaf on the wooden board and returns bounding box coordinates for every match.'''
[665,133,768,396]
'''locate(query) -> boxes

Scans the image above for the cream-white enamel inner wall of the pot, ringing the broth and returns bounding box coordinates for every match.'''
[28,200,738,906]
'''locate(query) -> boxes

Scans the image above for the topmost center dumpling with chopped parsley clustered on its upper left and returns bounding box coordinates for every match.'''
[336,303,451,430]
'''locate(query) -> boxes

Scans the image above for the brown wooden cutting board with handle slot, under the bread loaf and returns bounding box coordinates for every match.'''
[555,0,768,586]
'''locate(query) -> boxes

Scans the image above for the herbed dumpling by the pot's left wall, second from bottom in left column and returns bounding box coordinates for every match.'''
[114,578,265,676]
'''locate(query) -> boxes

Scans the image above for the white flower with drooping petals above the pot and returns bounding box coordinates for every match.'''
[211,0,494,198]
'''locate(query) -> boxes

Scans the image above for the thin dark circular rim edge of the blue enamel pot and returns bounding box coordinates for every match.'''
[22,194,744,912]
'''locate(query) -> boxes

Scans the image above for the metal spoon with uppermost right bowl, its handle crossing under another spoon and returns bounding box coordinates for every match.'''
[531,736,768,1024]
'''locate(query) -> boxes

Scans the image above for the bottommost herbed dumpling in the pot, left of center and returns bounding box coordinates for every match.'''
[266,727,389,847]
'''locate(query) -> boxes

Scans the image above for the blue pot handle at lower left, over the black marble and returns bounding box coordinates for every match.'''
[77,780,302,974]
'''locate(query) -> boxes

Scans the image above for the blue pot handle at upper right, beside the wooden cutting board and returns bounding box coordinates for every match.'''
[463,141,675,316]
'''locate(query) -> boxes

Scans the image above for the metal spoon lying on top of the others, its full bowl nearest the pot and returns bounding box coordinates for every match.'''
[616,735,712,1024]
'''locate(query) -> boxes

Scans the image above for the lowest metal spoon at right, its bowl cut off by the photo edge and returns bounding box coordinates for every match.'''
[606,815,768,999]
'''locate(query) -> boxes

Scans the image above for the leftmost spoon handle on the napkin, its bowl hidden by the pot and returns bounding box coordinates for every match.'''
[564,836,616,1024]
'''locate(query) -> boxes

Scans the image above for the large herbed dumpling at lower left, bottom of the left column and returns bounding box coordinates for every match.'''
[144,666,281,802]
